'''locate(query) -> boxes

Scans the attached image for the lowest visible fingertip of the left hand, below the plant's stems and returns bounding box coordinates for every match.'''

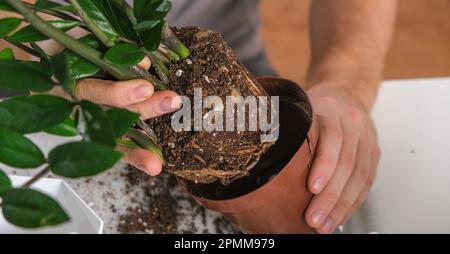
[118,146,162,176]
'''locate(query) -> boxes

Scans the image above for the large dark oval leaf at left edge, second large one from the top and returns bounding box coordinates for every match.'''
[0,94,73,133]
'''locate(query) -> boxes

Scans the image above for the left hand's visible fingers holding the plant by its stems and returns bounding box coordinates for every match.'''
[52,59,181,176]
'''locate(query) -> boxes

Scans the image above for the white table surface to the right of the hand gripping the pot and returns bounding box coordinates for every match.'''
[345,78,450,233]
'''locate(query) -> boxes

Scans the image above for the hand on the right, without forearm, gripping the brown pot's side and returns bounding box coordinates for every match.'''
[305,85,380,233]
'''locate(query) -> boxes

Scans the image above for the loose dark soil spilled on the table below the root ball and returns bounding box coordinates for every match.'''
[118,166,240,234]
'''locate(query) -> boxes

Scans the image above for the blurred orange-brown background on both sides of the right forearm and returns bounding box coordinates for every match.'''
[262,0,450,83]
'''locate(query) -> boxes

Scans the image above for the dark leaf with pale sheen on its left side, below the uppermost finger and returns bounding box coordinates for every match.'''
[76,101,116,147]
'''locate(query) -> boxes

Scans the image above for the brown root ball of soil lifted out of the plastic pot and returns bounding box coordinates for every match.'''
[148,27,271,184]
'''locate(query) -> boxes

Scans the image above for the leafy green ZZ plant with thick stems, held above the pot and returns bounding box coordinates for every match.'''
[0,0,190,228]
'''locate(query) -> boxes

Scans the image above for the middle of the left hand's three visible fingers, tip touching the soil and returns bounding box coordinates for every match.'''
[128,91,182,120]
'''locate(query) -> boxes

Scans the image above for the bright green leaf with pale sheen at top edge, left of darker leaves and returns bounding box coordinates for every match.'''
[74,0,118,42]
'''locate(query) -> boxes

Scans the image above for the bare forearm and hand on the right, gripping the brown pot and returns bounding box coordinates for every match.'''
[305,0,396,233]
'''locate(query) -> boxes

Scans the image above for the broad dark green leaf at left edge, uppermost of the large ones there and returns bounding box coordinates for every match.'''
[0,60,55,92]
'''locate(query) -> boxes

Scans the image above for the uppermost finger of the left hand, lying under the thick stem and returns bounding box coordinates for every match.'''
[76,79,154,107]
